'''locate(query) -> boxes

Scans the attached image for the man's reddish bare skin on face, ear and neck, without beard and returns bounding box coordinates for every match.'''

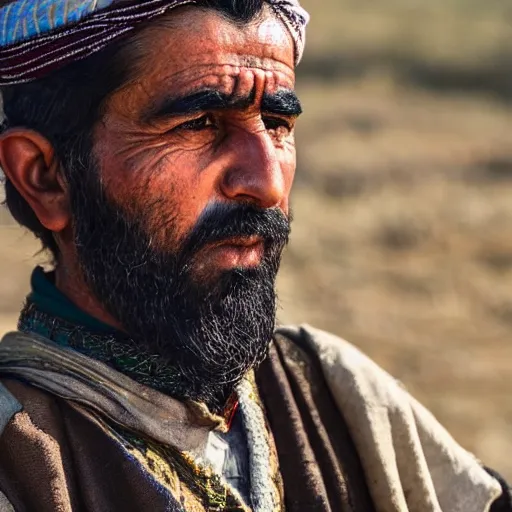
[0,7,296,328]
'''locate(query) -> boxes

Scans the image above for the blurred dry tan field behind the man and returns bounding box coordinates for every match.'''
[0,0,512,480]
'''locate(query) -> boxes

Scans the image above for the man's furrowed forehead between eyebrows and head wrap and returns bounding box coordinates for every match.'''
[112,7,295,111]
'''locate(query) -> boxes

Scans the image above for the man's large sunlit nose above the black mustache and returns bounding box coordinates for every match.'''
[221,131,286,208]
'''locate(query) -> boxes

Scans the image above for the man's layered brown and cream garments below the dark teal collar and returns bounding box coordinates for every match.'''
[0,268,506,512]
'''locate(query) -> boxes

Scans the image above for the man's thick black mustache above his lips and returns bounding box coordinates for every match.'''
[182,203,292,256]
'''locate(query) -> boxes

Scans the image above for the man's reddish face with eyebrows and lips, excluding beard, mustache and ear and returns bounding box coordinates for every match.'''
[95,8,299,279]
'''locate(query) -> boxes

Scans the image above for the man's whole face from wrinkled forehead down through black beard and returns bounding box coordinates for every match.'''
[70,8,300,406]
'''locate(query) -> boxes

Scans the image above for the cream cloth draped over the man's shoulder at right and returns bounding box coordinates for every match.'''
[276,325,512,512]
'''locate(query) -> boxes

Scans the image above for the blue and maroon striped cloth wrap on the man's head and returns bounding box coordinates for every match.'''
[0,0,309,86]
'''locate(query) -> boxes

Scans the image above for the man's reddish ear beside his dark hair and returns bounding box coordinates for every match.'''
[0,128,71,233]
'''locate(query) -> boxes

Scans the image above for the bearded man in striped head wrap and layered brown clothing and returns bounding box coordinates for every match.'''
[0,0,512,512]
